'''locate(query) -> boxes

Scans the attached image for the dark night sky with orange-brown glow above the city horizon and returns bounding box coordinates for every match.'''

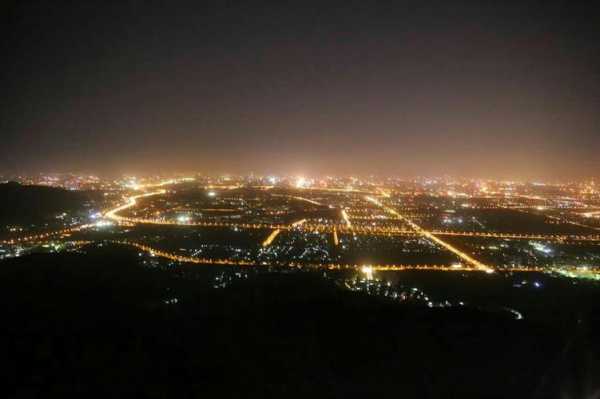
[0,0,600,179]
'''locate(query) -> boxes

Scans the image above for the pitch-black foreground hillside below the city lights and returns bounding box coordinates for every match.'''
[0,247,598,398]
